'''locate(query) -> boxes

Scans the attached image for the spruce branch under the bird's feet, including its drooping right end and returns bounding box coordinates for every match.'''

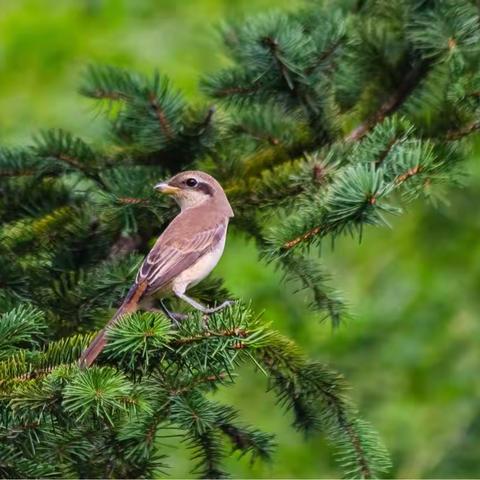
[3,308,383,478]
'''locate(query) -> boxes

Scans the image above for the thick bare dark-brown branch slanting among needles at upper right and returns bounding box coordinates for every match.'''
[345,63,428,142]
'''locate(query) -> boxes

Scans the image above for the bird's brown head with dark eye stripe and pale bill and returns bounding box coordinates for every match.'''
[155,170,233,217]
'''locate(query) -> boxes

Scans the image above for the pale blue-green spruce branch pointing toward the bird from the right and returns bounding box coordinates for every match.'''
[266,119,458,253]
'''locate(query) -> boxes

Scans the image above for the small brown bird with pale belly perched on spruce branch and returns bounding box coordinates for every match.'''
[79,170,234,367]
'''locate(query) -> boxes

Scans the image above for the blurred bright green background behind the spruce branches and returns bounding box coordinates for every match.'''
[0,0,480,478]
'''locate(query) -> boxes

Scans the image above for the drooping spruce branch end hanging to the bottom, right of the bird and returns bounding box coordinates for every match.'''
[257,336,390,478]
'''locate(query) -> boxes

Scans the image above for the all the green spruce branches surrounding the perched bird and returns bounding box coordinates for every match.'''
[0,0,480,478]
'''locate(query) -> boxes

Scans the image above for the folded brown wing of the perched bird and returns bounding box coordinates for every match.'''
[136,222,227,295]
